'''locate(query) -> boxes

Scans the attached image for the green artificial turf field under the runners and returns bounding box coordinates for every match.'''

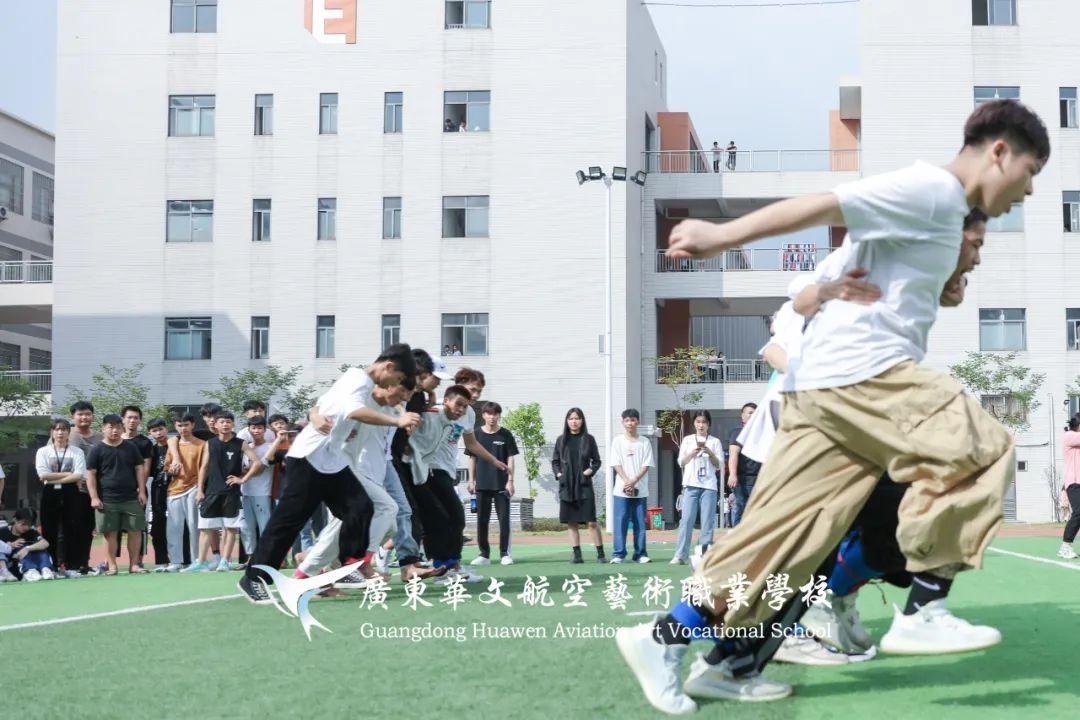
[0,538,1080,720]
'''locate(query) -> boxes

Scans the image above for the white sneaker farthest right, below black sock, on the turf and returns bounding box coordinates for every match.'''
[881,598,1001,655]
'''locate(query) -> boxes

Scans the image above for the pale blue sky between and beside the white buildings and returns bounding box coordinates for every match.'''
[0,0,859,144]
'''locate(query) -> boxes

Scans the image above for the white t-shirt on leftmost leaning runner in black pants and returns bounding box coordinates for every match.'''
[286,367,375,475]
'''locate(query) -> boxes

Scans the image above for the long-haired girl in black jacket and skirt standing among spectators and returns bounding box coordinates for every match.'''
[551,408,607,563]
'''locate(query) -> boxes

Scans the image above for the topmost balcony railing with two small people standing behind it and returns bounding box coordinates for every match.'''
[643,150,860,173]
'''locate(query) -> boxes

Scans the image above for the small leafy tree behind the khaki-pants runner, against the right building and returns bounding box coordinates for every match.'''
[949,352,1047,433]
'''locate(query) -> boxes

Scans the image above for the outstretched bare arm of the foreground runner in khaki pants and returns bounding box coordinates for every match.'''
[666,192,845,259]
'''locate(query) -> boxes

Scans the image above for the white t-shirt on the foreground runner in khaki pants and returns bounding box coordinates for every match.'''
[784,162,969,392]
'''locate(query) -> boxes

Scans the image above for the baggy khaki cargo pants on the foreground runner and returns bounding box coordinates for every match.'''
[699,362,1015,627]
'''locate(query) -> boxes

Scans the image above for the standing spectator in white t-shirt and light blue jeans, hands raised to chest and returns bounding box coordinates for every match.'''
[671,410,724,565]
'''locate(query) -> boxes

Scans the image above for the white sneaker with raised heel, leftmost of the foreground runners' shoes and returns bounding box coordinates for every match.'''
[615,622,698,715]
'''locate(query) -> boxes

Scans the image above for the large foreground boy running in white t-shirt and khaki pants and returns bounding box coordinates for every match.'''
[616,100,1050,714]
